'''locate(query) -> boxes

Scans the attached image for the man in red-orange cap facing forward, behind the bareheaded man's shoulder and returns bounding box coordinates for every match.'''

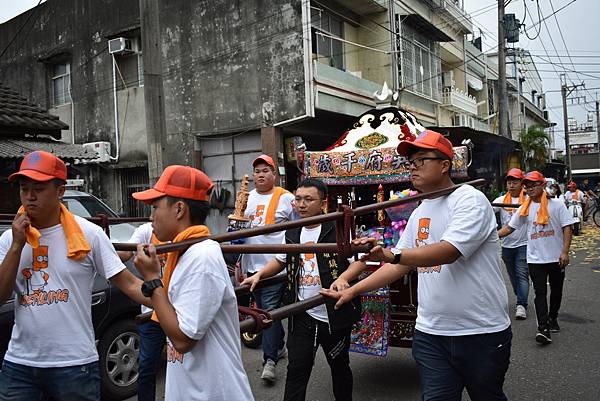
[242,155,294,382]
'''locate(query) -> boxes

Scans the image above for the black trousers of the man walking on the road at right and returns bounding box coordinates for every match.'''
[528,262,565,329]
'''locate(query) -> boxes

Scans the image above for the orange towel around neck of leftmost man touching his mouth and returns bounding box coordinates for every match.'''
[17,203,91,260]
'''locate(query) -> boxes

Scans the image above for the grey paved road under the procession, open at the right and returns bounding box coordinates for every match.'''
[125,226,600,401]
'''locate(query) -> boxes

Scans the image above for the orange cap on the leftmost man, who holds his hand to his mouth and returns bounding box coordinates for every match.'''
[8,150,67,182]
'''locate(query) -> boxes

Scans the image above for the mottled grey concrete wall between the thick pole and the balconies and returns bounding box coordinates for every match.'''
[160,0,306,163]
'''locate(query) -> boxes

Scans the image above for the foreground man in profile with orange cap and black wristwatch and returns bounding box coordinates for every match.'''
[133,165,253,401]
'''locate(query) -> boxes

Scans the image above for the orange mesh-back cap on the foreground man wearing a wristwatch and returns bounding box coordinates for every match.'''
[131,165,214,203]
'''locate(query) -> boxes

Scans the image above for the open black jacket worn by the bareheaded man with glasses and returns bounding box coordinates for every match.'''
[283,222,360,331]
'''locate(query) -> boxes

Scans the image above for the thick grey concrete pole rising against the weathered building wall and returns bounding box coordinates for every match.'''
[139,0,167,183]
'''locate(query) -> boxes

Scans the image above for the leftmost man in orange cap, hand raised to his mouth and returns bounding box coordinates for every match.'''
[0,151,151,401]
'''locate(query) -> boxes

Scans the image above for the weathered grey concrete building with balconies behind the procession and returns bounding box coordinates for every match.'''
[0,0,552,230]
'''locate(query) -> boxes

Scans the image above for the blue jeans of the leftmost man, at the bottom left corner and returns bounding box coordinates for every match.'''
[0,361,100,401]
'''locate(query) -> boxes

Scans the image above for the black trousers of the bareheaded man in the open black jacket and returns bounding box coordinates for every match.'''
[283,312,352,401]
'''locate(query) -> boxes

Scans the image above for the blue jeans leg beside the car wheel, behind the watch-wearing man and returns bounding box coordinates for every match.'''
[138,322,166,401]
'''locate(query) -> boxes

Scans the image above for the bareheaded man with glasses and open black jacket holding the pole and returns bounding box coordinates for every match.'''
[242,179,360,401]
